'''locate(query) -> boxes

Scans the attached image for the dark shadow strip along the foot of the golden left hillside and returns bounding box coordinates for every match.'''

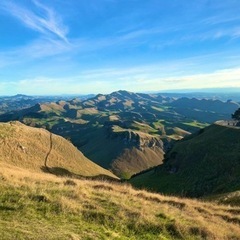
[41,166,120,182]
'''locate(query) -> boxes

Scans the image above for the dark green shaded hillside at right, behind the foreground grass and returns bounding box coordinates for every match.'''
[131,125,240,196]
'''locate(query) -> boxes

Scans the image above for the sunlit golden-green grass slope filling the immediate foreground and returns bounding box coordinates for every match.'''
[0,164,240,239]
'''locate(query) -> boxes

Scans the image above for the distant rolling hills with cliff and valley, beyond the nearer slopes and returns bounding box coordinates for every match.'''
[0,91,239,178]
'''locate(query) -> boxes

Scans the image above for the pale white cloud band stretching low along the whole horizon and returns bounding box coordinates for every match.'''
[3,67,240,95]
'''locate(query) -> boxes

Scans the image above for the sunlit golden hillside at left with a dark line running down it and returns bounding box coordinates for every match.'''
[0,122,114,177]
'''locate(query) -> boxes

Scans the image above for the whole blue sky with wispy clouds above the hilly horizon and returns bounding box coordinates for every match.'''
[0,0,240,95]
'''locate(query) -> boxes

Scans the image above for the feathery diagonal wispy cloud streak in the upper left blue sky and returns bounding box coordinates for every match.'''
[0,0,68,42]
